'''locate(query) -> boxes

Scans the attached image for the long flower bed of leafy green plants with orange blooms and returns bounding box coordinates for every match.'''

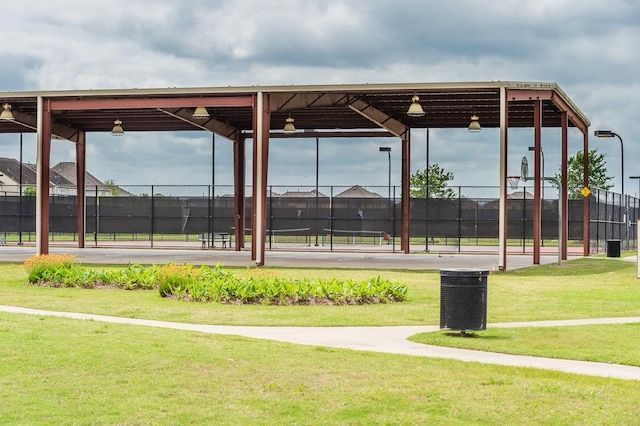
[25,255,407,305]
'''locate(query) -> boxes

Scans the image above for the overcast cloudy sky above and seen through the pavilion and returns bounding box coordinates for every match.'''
[0,0,640,196]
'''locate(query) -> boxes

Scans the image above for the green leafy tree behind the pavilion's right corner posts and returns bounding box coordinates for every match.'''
[551,149,613,200]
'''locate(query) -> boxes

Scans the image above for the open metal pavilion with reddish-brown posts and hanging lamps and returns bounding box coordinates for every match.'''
[0,81,590,269]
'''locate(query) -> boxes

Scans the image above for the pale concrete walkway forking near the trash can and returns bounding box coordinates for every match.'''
[0,305,640,380]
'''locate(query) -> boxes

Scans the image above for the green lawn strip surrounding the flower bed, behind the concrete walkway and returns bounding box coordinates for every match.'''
[0,258,640,326]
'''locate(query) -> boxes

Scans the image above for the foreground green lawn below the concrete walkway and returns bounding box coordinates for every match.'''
[0,314,640,425]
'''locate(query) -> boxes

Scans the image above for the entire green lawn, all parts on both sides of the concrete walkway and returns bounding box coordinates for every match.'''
[0,258,640,425]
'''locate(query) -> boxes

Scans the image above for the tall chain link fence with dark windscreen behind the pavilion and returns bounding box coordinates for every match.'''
[0,185,640,253]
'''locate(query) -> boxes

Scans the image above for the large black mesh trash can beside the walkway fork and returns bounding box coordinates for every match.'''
[440,268,489,332]
